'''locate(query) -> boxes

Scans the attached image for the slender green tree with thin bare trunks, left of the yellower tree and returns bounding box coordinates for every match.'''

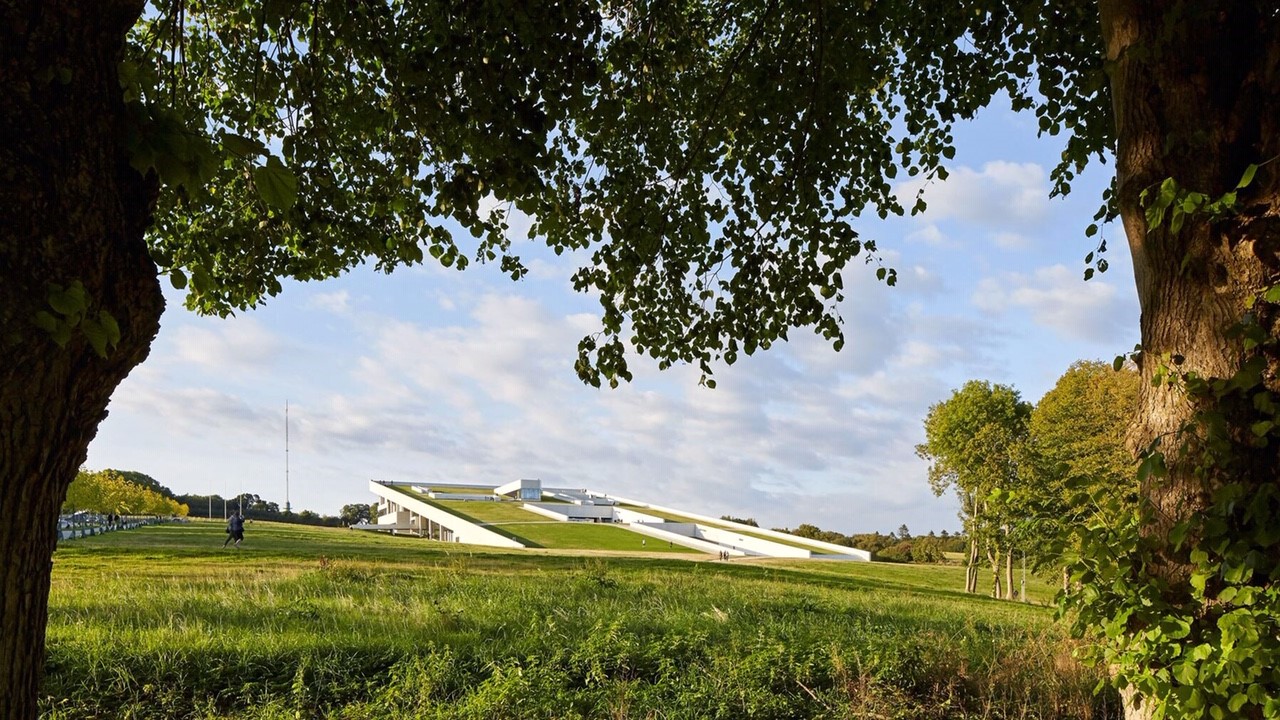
[916,380,1030,597]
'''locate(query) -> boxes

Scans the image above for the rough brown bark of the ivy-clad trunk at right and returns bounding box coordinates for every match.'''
[1100,0,1280,717]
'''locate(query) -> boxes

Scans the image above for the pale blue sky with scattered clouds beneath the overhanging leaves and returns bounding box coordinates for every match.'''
[86,96,1138,533]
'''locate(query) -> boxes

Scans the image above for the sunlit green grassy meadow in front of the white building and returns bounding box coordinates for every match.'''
[42,523,1119,720]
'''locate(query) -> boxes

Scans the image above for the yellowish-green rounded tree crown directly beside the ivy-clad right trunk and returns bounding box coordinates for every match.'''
[1019,361,1140,584]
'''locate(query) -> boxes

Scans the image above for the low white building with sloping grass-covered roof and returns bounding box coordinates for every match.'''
[356,479,870,562]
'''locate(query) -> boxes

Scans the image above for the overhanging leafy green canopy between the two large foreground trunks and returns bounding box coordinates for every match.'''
[129,0,1111,384]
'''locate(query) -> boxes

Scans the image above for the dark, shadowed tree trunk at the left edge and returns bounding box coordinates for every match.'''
[0,0,164,720]
